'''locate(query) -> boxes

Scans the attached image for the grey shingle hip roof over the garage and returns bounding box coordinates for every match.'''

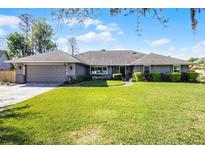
[7,50,81,63]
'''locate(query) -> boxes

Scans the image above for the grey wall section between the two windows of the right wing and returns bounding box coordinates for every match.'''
[151,65,173,73]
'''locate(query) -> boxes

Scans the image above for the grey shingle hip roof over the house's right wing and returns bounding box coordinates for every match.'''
[130,53,193,65]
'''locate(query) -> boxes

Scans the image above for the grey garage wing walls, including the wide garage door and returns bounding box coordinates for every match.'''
[16,63,89,83]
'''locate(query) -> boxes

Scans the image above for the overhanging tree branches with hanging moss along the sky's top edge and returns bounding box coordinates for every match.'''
[52,8,204,34]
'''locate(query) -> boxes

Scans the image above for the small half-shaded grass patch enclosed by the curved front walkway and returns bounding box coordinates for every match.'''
[81,80,125,87]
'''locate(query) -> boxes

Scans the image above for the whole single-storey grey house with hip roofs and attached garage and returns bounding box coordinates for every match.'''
[7,50,192,83]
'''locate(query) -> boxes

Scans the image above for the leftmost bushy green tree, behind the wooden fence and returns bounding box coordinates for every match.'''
[7,32,27,58]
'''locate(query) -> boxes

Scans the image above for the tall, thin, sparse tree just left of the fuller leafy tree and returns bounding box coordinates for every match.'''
[19,13,33,55]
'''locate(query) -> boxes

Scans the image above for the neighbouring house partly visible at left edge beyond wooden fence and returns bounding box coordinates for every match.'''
[0,50,12,70]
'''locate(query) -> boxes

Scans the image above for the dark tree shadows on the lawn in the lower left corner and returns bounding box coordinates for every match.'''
[0,105,29,144]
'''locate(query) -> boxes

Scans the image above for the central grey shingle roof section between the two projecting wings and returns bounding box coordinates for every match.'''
[76,50,145,65]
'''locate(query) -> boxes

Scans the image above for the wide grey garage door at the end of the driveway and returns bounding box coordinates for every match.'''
[27,65,66,83]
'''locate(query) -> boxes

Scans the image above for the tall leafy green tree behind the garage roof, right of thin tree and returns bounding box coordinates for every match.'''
[31,19,56,54]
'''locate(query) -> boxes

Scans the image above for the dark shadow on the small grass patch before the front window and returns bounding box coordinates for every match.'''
[81,80,108,87]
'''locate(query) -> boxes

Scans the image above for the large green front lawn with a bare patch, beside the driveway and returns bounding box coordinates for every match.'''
[0,82,205,144]
